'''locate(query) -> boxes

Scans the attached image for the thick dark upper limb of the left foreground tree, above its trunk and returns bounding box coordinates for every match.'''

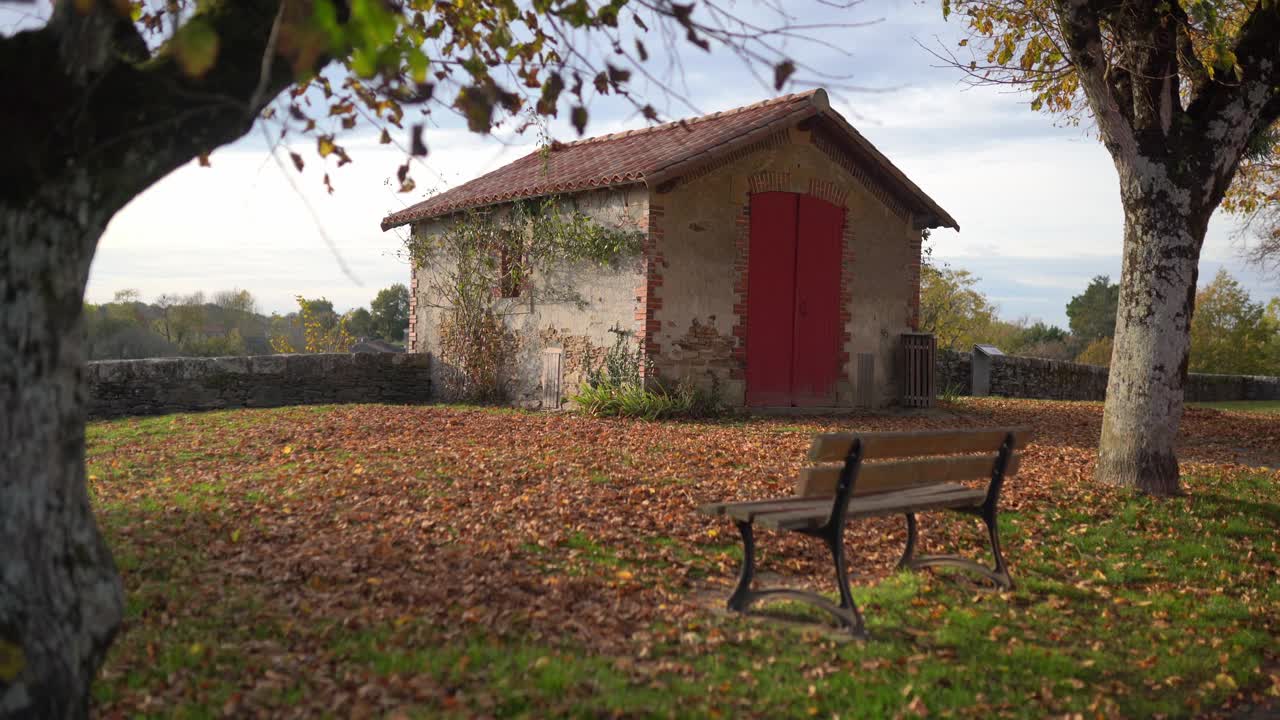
[0,0,345,215]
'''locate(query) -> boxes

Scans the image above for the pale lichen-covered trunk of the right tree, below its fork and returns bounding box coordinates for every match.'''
[1097,176,1207,496]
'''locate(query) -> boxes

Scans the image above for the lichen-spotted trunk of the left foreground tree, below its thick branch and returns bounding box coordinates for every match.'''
[0,183,123,717]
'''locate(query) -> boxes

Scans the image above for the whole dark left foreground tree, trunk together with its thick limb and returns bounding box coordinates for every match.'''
[0,0,335,717]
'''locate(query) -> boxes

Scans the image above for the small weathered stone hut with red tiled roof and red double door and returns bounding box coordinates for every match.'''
[381,90,959,407]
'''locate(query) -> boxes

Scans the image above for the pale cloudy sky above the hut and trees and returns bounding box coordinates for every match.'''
[0,0,1280,327]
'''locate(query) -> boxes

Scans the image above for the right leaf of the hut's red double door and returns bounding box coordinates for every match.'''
[791,195,845,406]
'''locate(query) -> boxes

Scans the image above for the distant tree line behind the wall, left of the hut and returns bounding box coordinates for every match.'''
[84,283,408,360]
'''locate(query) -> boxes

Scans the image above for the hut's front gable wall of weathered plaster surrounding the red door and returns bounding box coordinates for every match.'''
[646,128,920,406]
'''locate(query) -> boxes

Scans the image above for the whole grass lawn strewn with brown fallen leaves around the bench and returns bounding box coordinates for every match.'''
[88,400,1280,719]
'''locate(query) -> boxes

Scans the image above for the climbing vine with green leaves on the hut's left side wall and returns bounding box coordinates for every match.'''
[407,197,644,402]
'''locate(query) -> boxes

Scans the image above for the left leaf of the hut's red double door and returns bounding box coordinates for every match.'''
[746,192,797,406]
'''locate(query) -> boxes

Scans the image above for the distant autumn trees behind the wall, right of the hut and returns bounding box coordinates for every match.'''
[920,261,1280,375]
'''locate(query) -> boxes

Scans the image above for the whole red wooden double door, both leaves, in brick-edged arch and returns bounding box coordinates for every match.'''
[746,192,845,406]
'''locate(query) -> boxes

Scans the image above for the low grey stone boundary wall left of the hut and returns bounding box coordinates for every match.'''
[84,352,431,419]
